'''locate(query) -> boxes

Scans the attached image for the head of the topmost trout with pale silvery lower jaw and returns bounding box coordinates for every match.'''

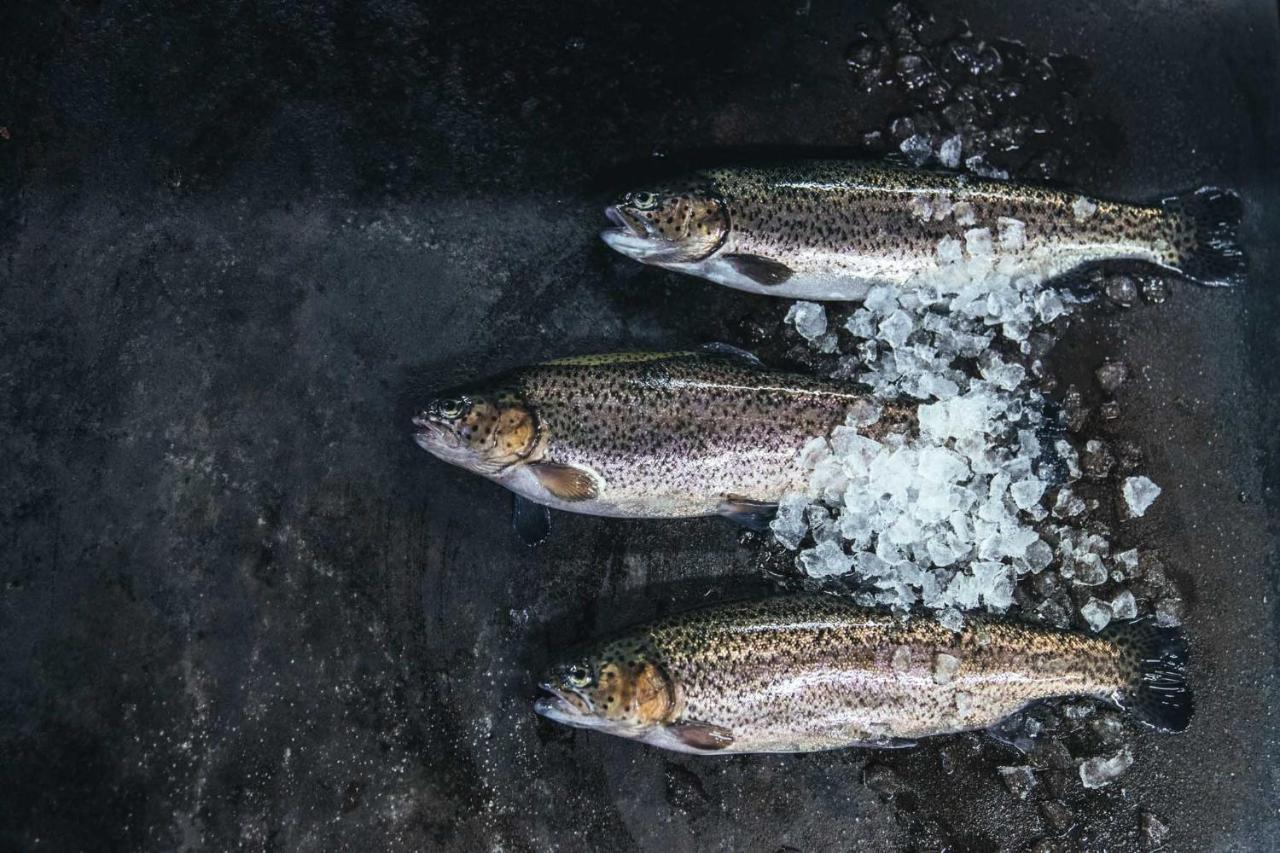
[600,181,730,266]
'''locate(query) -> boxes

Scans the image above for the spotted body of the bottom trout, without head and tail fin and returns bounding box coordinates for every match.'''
[563,596,1132,752]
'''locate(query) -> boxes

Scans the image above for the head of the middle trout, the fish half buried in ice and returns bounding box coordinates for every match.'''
[413,387,538,475]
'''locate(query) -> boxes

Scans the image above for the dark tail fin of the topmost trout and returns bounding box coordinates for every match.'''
[1161,187,1248,287]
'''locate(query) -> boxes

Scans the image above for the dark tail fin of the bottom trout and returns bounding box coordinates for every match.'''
[1103,620,1193,731]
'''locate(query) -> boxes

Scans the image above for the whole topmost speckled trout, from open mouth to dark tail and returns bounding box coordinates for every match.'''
[602,161,1244,301]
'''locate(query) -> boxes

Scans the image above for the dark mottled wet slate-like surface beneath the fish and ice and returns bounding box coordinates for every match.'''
[0,0,1280,850]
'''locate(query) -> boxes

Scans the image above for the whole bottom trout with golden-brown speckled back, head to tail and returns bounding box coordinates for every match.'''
[535,596,1190,753]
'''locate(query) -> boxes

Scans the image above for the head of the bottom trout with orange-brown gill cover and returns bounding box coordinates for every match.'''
[534,639,675,739]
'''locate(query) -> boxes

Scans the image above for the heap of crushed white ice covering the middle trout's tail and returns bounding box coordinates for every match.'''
[772,222,1153,628]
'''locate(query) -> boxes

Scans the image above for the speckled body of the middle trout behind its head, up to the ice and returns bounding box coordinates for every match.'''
[511,352,909,516]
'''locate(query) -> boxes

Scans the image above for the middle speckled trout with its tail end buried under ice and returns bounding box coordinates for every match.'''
[415,352,914,517]
